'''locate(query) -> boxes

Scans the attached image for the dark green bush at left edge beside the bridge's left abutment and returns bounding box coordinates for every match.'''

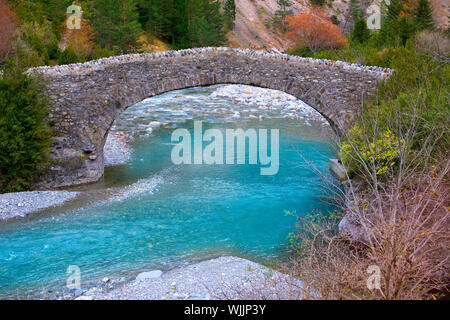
[0,61,50,192]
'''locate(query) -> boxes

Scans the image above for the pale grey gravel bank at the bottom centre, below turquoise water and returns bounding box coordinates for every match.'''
[75,256,302,300]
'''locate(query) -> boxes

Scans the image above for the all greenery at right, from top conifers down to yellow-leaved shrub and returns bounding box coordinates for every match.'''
[291,0,450,195]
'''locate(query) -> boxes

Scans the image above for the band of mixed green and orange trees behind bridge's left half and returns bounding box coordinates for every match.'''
[1,0,236,65]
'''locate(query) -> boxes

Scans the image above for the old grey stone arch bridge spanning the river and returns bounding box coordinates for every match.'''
[29,48,391,189]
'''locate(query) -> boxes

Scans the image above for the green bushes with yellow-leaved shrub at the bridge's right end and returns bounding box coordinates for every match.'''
[335,38,450,180]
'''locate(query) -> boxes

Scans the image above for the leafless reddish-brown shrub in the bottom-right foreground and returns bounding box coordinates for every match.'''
[281,162,450,299]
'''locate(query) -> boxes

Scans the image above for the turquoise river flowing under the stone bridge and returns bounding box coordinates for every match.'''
[0,86,333,297]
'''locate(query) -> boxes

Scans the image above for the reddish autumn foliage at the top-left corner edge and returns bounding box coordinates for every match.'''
[0,0,17,61]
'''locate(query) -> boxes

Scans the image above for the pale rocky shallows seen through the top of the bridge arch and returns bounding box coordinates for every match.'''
[104,84,331,171]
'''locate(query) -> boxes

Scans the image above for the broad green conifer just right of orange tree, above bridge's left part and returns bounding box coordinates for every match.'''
[93,0,141,52]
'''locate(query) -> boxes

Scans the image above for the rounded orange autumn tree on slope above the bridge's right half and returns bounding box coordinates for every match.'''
[286,10,347,53]
